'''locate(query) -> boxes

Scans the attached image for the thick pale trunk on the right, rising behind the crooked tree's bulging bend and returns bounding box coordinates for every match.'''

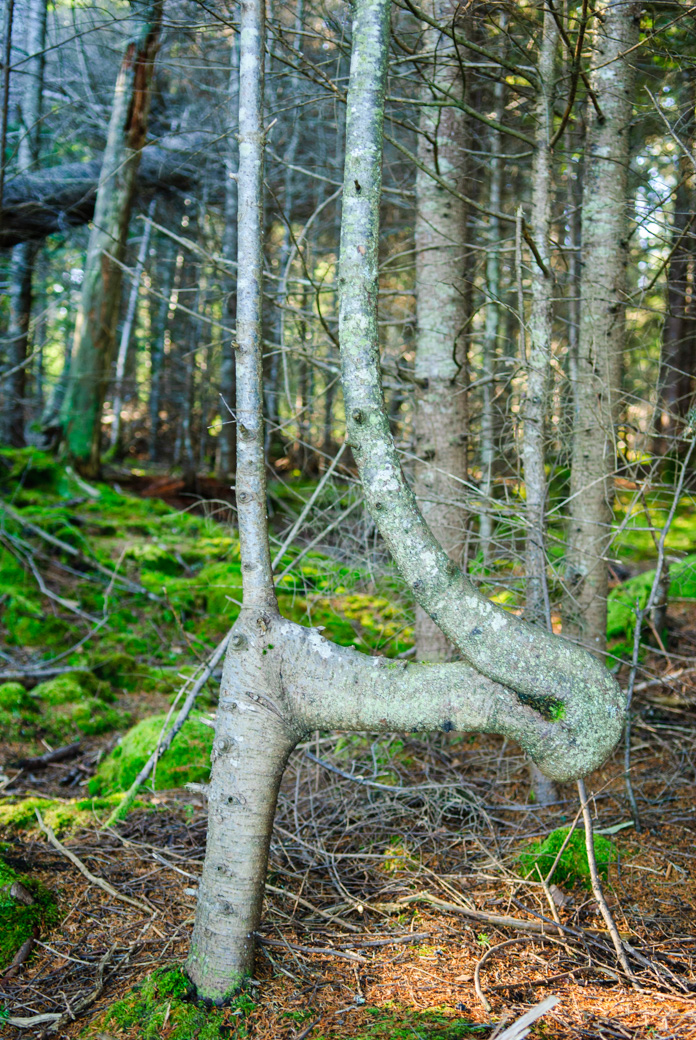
[564,0,641,655]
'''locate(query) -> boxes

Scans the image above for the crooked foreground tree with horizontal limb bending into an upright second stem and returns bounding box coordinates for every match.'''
[188,0,622,1003]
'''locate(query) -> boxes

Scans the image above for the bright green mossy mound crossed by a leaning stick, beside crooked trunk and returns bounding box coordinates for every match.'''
[89,714,214,795]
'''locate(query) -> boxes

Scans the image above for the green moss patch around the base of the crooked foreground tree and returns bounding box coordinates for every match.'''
[82,967,249,1040]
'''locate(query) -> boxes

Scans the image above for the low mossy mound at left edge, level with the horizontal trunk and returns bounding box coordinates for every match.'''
[0,672,130,743]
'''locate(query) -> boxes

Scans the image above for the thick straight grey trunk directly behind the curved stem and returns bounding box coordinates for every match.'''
[415,0,467,660]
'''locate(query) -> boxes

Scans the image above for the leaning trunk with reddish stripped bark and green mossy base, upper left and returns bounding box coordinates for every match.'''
[60,0,162,477]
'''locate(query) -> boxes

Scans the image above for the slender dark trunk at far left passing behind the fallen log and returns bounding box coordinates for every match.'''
[0,0,48,447]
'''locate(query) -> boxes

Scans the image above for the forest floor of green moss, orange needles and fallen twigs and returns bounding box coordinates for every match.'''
[0,451,696,1040]
